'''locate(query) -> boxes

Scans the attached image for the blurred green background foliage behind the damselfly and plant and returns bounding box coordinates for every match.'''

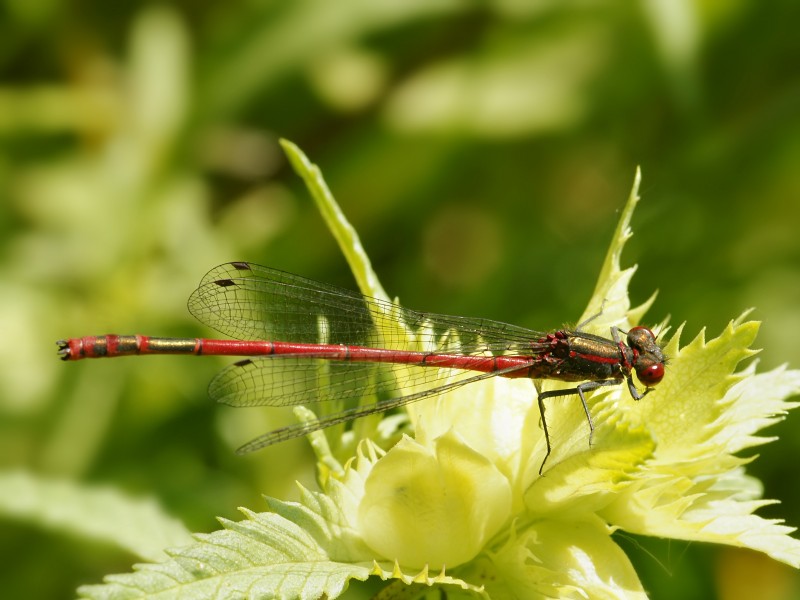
[0,0,800,599]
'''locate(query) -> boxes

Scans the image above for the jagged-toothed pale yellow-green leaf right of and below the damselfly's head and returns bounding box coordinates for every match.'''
[601,315,800,567]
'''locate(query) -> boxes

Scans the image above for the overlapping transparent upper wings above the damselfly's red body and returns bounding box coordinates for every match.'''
[189,262,543,354]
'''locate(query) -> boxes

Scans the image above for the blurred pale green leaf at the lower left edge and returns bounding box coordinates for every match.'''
[0,471,191,560]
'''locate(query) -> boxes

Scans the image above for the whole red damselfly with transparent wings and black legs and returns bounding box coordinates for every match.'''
[58,262,665,473]
